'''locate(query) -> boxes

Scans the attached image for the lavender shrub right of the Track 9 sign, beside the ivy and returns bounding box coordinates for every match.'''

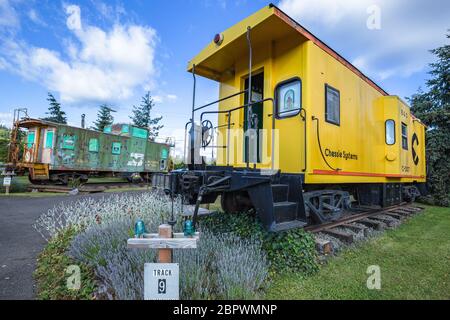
[174,231,268,300]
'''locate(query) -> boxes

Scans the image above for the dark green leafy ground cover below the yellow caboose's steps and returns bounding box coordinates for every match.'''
[200,212,318,275]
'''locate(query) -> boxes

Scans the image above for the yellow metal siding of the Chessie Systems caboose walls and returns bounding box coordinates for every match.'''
[206,6,425,184]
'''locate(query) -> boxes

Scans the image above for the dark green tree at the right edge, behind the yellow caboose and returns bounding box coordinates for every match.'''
[408,34,450,206]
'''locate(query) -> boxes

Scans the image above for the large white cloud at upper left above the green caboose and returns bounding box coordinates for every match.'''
[0,4,157,102]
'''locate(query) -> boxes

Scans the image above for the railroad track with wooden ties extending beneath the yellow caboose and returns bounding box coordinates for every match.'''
[305,203,424,254]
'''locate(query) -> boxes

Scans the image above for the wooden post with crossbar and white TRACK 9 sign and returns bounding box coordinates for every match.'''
[128,224,199,300]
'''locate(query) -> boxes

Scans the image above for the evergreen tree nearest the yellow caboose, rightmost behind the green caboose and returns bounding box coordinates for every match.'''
[130,92,164,140]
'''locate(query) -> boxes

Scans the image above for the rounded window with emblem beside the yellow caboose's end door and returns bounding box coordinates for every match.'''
[275,78,302,118]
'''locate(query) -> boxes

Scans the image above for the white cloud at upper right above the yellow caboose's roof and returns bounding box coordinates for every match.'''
[279,0,450,80]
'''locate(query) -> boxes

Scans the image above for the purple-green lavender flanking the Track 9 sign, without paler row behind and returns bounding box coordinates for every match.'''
[69,221,268,300]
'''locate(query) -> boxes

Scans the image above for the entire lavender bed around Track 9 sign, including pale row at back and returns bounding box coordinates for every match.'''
[34,192,268,300]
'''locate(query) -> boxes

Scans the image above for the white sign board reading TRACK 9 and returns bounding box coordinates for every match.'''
[144,263,180,300]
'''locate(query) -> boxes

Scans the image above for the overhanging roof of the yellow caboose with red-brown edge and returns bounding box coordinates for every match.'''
[188,4,388,95]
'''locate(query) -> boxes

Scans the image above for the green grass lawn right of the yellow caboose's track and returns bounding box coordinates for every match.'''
[266,207,450,299]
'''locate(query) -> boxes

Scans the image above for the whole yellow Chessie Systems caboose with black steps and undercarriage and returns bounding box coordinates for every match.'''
[155,5,426,231]
